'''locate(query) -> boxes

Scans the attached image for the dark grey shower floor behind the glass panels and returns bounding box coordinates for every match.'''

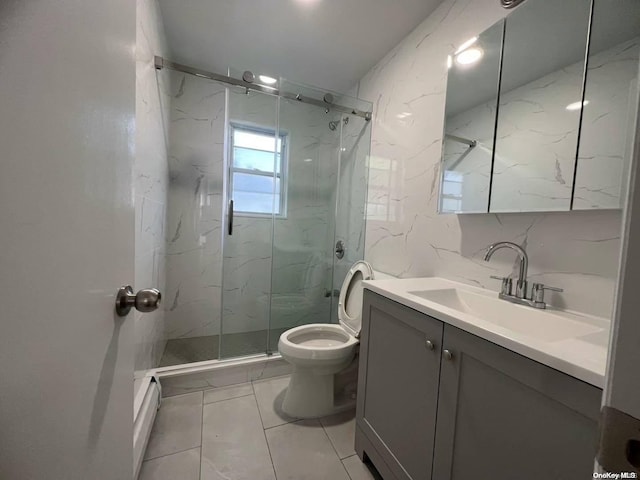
[158,328,287,367]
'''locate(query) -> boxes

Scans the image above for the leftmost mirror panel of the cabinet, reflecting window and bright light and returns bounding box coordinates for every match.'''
[440,21,504,213]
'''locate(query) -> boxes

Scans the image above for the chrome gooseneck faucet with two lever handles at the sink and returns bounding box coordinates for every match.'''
[484,242,563,308]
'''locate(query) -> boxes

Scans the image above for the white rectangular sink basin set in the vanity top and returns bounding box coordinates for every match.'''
[407,288,602,342]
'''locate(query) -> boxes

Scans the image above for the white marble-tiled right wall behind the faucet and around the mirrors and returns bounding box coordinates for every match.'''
[358,0,621,317]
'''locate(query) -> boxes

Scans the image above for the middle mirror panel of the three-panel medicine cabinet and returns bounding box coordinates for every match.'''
[490,0,590,212]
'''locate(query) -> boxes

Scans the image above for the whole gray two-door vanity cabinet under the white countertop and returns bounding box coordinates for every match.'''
[356,290,602,480]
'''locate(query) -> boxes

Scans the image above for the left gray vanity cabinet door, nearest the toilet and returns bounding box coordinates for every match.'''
[356,290,443,480]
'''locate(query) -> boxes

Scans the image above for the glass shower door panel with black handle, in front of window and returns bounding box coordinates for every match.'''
[220,88,278,358]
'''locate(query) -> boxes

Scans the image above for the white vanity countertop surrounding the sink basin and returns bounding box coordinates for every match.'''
[363,277,610,388]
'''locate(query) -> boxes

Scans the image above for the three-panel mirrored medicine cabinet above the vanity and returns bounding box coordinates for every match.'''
[439,0,640,213]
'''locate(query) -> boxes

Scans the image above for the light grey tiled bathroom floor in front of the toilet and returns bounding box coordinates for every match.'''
[139,375,381,480]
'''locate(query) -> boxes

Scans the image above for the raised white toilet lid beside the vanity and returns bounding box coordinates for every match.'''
[338,261,373,338]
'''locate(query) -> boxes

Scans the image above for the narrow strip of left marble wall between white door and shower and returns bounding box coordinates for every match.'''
[133,0,168,373]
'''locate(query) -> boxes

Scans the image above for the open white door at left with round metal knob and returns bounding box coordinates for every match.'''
[0,0,135,480]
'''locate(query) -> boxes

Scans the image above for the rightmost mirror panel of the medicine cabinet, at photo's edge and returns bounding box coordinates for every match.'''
[573,0,640,210]
